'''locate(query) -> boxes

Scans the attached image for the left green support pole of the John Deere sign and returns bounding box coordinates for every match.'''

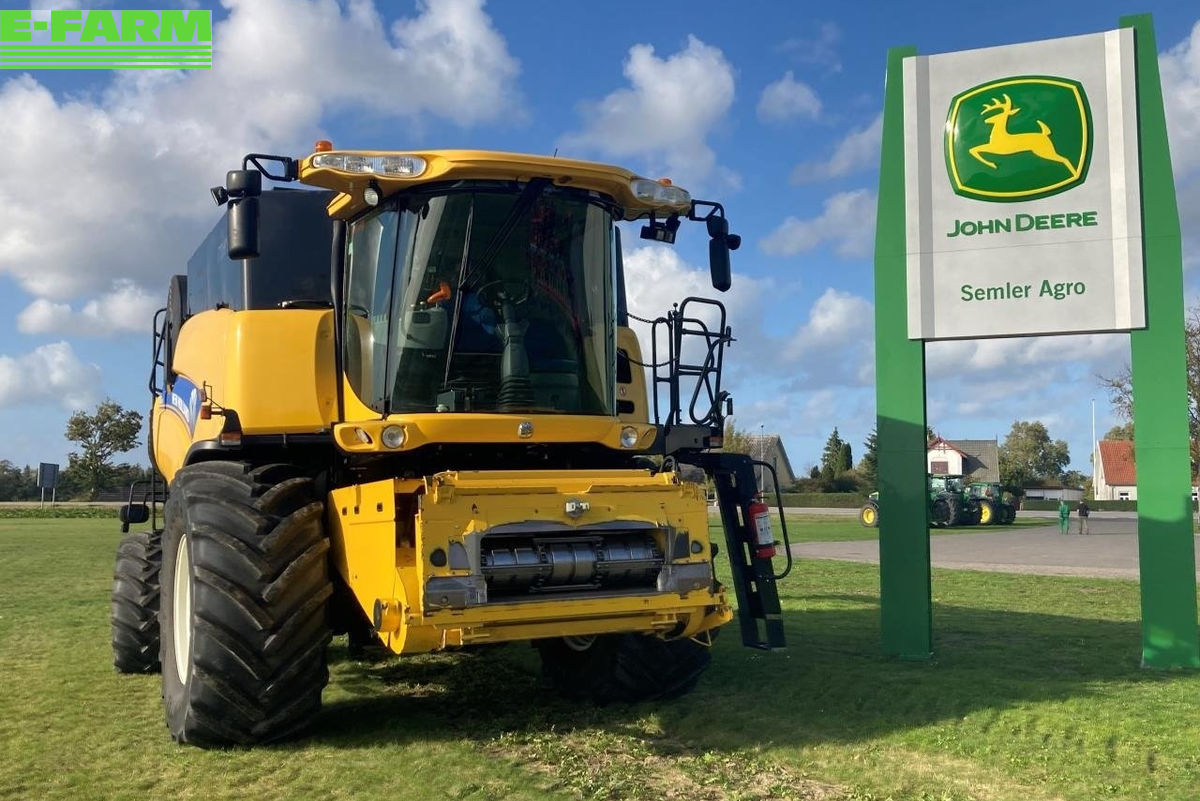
[875,47,932,660]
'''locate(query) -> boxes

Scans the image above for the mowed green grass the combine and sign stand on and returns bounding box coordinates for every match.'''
[0,518,1200,801]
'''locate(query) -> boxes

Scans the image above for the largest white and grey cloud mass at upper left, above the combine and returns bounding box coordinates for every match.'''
[0,0,522,303]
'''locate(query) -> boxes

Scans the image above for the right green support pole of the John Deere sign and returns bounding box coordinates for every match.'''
[1123,14,1200,668]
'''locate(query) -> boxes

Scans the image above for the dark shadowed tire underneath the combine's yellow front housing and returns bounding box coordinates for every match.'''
[534,632,715,704]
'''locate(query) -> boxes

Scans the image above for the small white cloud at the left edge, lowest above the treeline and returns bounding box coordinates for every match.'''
[0,342,100,410]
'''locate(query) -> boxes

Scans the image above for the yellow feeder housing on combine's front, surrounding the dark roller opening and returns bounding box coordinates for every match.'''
[328,470,732,654]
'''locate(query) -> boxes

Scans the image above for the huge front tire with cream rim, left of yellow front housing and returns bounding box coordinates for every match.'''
[160,462,331,746]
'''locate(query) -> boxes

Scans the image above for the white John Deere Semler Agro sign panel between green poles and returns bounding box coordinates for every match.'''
[904,30,1145,339]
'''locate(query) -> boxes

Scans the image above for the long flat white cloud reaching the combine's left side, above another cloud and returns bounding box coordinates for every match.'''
[17,279,163,337]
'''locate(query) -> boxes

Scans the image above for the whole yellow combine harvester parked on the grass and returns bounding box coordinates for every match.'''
[113,143,784,745]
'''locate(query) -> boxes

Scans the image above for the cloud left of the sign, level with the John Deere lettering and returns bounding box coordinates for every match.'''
[758,189,875,259]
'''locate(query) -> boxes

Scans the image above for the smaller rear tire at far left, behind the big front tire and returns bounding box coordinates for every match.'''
[112,530,162,673]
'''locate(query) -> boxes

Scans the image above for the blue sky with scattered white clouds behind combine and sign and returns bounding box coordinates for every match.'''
[0,0,1200,474]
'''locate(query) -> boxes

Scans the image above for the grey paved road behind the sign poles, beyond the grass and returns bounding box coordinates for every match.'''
[792,512,1200,579]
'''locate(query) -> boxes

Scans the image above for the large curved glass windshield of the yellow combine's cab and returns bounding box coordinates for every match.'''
[343,181,616,415]
